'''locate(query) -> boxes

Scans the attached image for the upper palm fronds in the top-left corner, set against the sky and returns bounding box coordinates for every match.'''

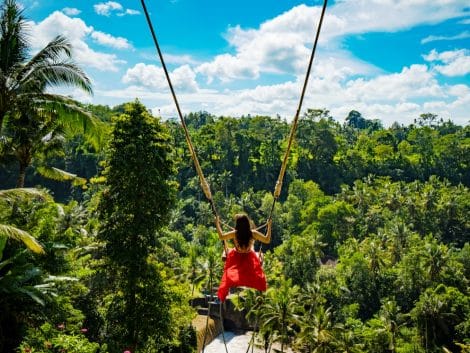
[0,0,92,133]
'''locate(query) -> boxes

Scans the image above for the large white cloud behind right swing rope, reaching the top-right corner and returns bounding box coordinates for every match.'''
[196,0,466,83]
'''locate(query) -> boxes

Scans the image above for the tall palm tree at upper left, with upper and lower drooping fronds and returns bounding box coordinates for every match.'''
[0,0,102,187]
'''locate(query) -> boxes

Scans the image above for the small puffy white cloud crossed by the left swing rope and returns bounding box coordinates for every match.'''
[122,63,199,92]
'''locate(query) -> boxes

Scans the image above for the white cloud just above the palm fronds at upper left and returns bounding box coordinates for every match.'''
[30,11,124,71]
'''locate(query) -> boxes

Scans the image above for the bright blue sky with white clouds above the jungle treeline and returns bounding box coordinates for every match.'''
[19,0,470,126]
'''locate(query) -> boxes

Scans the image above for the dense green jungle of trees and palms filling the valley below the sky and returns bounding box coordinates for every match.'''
[0,0,470,353]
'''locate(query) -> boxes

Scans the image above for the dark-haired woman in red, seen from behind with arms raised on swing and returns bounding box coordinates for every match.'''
[215,214,272,301]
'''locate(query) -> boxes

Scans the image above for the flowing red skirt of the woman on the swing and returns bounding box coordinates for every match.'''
[217,249,266,301]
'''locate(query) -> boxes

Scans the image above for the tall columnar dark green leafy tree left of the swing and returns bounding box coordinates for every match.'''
[94,101,179,351]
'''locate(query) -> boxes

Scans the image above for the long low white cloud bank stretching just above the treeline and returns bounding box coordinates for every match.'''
[107,64,470,126]
